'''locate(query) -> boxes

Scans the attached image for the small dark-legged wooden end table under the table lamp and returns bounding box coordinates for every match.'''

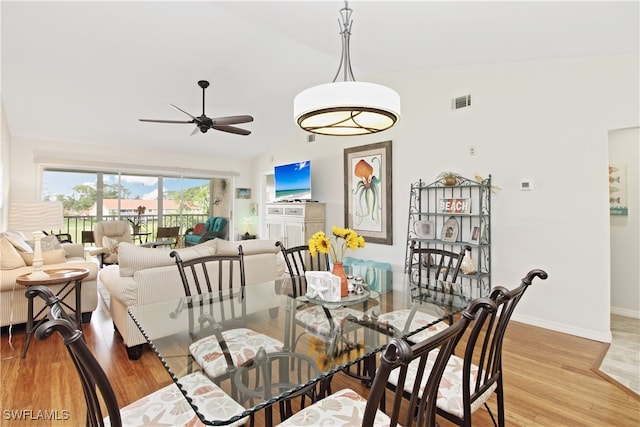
[16,268,89,358]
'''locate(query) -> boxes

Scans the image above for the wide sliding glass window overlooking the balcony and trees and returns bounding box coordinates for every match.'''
[42,168,233,242]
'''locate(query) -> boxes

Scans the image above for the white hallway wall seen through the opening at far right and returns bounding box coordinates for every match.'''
[609,128,640,319]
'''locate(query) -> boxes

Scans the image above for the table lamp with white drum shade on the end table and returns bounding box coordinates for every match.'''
[9,200,64,279]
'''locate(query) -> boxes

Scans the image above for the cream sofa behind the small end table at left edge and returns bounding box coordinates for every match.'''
[0,233,99,327]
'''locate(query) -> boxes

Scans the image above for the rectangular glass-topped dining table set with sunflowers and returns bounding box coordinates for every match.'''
[129,271,470,425]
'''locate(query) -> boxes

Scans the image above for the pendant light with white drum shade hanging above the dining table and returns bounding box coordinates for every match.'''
[293,1,400,136]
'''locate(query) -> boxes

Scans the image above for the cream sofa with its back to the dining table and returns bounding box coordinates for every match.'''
[99,239,285,360]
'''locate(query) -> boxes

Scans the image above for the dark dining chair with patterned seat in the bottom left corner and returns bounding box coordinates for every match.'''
[25,285,247,427]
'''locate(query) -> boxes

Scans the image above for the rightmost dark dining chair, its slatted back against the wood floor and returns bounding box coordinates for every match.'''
[389,270,547,426]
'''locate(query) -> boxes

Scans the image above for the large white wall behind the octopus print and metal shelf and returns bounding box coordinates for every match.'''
[254,56,640,342]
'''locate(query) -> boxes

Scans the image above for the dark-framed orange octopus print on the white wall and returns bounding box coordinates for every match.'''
[344,141,393,245]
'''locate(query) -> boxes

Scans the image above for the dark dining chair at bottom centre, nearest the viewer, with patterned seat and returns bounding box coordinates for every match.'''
[280,298,495,427]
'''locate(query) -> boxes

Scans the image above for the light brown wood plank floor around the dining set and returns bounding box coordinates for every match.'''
[0,296,640,427]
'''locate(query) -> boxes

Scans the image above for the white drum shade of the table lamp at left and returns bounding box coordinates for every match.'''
[9,200,64,231]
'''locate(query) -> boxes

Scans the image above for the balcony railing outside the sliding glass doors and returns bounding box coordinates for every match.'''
[55,214,209,243]
